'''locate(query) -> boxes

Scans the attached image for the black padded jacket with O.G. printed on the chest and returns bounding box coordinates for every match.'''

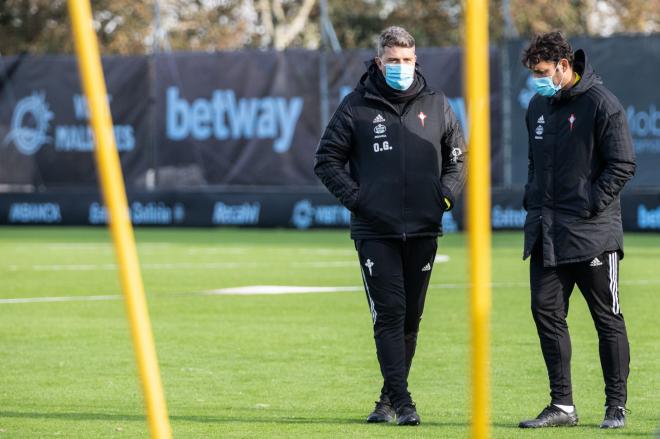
[314,63,465,239]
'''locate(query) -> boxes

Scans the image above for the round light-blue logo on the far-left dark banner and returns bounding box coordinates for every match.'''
[4,92,53,155]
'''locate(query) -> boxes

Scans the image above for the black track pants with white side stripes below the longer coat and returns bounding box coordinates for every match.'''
[530,245,630,406]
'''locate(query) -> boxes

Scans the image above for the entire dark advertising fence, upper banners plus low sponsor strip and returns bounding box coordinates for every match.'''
[0,36,660,231]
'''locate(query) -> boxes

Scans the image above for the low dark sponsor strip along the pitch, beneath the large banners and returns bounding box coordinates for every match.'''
[0,189,660,233]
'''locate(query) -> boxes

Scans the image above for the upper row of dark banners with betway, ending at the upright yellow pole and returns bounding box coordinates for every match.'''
[0,48,502,190]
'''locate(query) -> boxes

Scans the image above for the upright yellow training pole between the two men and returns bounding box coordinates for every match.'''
[465,0,491,439]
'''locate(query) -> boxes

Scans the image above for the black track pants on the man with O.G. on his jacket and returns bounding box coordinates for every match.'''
[355,238,438,407]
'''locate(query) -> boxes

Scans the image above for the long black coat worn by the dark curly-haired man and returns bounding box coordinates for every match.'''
[523,50,635,267]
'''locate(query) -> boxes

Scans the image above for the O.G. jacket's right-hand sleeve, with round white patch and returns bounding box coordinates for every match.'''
[440,96,467,206]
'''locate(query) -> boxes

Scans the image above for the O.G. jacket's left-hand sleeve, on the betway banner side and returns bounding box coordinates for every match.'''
[314,96,359,211]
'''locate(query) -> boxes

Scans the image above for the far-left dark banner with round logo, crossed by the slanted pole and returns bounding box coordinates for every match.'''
[0,56,150,189]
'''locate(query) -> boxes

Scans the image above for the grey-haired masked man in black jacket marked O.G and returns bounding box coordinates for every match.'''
[314,27,465,425]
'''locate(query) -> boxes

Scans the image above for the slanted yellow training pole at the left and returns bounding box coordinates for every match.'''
[68,0,172,438]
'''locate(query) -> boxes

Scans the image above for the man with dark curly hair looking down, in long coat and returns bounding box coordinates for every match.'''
[520,32,635,428]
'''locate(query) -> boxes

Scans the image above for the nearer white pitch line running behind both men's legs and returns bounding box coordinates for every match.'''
[0,279,660,305]
